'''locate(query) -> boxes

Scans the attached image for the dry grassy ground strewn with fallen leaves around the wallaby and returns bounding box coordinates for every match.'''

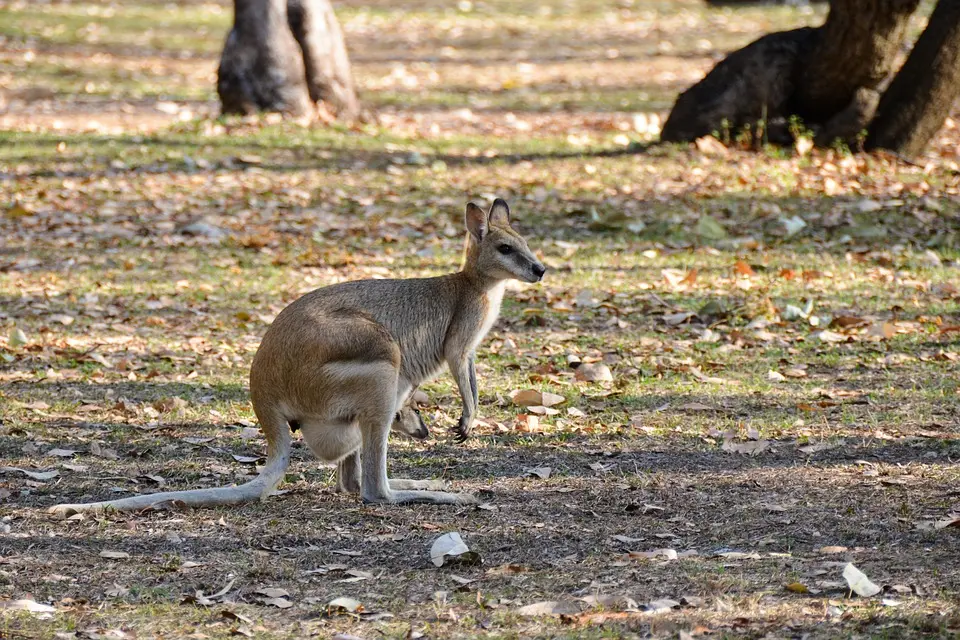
[0,0,960,638]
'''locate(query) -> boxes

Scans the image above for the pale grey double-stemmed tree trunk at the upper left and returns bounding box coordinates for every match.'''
[217,0,359,120]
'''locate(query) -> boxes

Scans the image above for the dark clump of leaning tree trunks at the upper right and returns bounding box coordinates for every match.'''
[661,0,960,155]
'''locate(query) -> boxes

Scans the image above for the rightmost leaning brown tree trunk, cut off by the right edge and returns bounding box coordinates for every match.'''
[866,0,960,156]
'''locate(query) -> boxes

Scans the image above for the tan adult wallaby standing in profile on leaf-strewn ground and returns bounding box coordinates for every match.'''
[50,198,546,516]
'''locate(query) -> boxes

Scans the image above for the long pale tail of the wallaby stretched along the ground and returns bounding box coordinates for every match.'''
[49,415,292,517]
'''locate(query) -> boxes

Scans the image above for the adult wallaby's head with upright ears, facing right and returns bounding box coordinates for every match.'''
[464,198,547,282]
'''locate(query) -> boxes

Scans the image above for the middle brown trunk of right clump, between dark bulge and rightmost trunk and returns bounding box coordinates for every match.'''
[791,0,919,123]
